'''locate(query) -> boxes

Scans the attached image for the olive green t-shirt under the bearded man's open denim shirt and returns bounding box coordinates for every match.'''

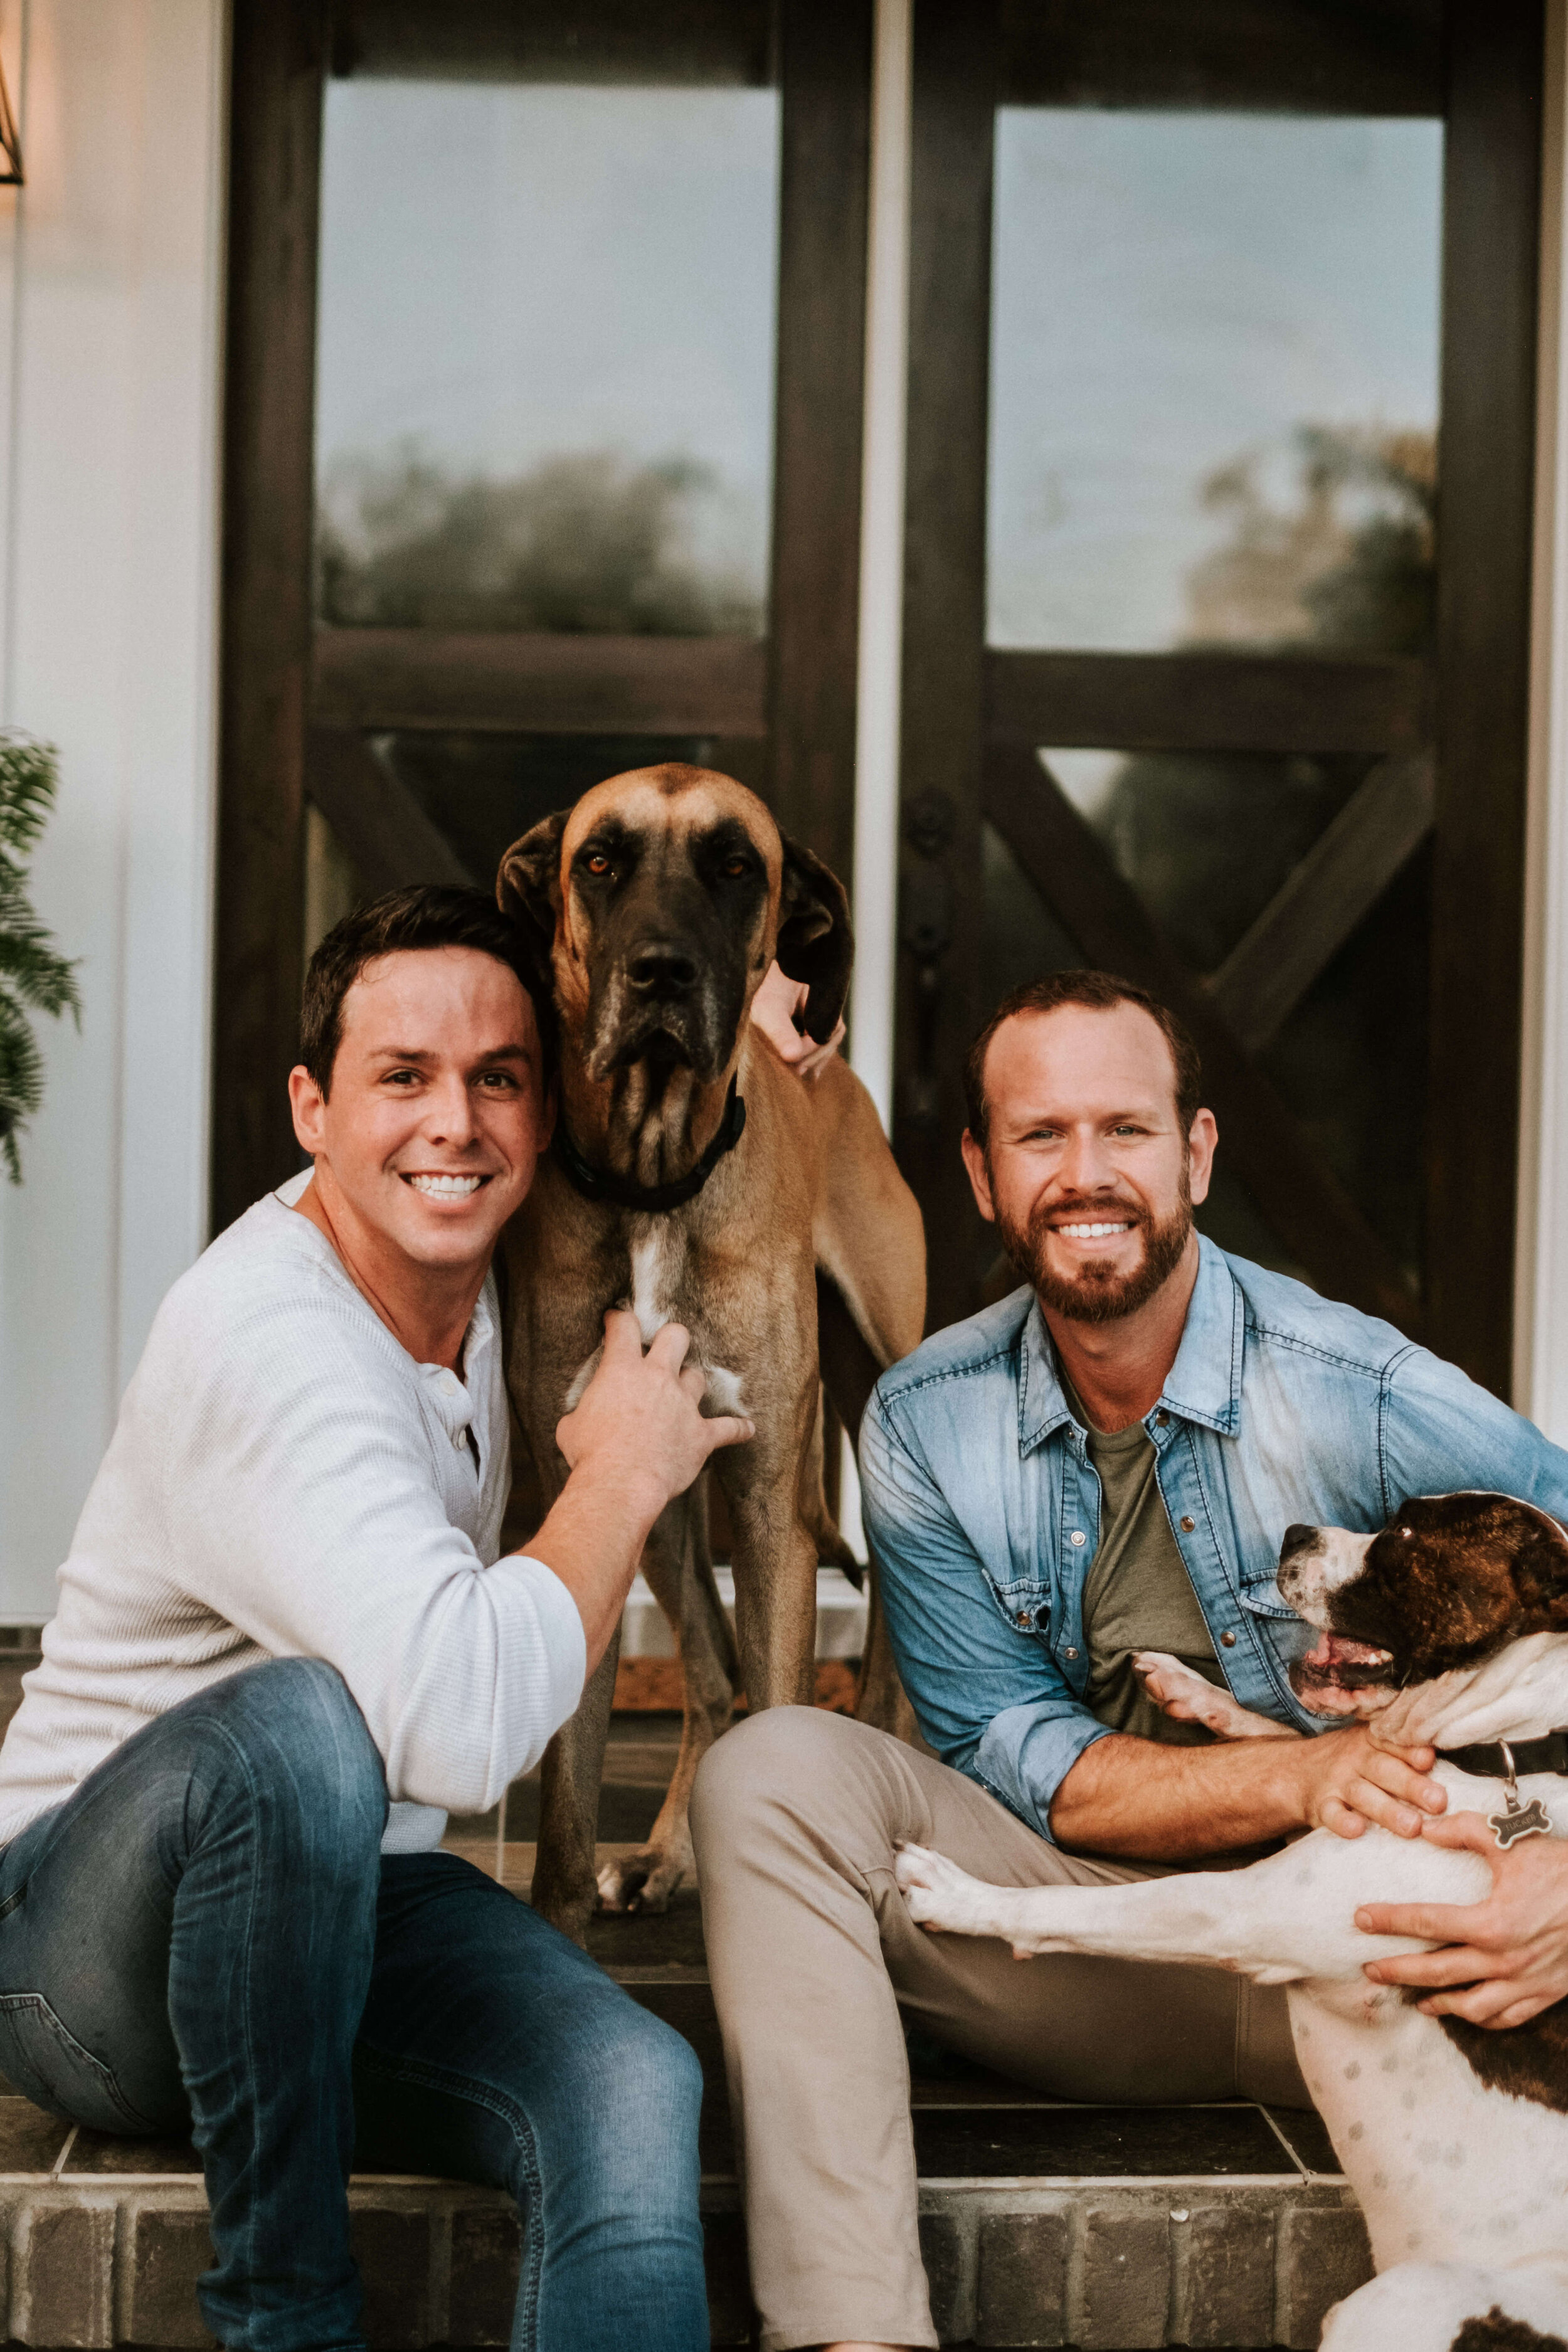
[1062,1374,1225,1747]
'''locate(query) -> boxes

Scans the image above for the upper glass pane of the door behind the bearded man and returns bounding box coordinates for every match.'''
[987,106,1443,654]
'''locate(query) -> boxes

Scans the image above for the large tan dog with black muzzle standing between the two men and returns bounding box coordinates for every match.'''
[496,767,926,1936]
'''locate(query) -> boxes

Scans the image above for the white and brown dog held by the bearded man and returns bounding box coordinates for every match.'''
[898,1493,1568,2352]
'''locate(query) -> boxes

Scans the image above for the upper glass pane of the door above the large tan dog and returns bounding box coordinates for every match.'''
[317,78,778,635]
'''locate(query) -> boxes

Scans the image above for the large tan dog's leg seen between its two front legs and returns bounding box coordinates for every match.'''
[600,1480,736,1910]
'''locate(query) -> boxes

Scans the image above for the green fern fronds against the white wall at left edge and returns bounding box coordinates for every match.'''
[0,734,82,1183]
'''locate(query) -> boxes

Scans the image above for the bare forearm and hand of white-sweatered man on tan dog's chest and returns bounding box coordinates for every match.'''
[529,1308,757,1675]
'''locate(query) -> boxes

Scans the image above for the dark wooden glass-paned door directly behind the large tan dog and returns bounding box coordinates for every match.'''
[211,0,870,1228]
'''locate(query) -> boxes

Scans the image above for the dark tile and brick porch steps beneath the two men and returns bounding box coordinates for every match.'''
[0,1658,1368,2352]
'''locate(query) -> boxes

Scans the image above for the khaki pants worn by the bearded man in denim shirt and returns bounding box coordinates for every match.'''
[691,1708,1310,2352]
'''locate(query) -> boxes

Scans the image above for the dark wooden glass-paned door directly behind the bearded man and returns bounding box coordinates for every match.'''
[896,0,1542,1395]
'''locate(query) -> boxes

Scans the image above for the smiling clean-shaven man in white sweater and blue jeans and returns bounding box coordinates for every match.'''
[0,889,752,2352]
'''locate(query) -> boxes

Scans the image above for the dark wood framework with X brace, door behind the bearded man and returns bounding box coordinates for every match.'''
[896,0,1545,1395]
